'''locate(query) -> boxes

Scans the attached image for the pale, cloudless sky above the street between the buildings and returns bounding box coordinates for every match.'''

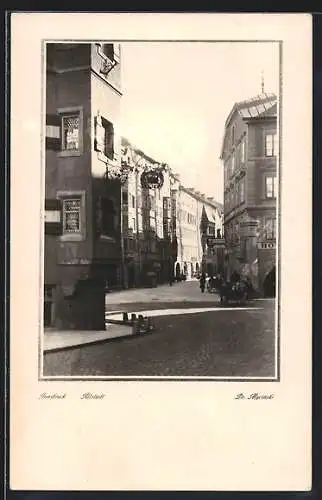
[120,42,279,202]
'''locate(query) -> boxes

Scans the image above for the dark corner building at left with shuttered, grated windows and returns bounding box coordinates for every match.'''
[44,43,122,329]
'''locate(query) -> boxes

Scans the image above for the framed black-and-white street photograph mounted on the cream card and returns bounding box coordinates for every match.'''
[40,39,283,380]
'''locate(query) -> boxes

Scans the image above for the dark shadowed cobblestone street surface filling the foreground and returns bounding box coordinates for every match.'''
[44,298,276,378]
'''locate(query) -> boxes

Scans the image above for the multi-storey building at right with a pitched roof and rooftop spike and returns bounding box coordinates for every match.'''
[221,93,278,296]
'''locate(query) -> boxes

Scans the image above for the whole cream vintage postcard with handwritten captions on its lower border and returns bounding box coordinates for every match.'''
[10,13,312,491]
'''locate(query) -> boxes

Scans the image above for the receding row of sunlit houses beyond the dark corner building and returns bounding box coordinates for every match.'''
[121,138,223,287]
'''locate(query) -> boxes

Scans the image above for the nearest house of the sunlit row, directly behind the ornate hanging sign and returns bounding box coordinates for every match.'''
[121,138,175,288]
